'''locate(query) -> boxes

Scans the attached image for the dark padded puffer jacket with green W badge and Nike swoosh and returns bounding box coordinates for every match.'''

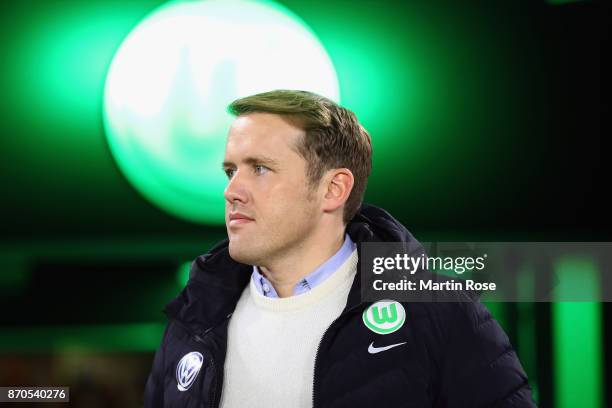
[145,205,535,408]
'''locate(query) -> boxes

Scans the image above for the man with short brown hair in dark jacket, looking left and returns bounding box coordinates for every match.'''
[145,91,534,408]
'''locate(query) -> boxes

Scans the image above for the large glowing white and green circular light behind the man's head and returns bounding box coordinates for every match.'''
[104,0,339,224]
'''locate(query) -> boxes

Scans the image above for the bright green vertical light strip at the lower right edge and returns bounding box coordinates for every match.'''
[552,257,603,408]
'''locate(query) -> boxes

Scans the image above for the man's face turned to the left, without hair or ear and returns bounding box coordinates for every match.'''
[223,113,322,265]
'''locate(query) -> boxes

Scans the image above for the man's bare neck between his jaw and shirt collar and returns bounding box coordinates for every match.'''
[259,227,344,298]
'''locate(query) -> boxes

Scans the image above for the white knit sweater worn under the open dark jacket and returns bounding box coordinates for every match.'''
[221,251,357,408]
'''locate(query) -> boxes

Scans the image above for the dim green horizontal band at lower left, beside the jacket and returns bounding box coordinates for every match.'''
[0,323,165,353]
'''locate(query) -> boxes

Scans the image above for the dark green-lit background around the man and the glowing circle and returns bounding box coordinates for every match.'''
[0,0,612,407]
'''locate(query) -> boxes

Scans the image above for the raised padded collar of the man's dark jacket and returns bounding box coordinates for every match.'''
[164,203,420,333]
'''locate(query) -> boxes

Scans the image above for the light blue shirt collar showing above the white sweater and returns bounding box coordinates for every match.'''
[251,234,356,298]
